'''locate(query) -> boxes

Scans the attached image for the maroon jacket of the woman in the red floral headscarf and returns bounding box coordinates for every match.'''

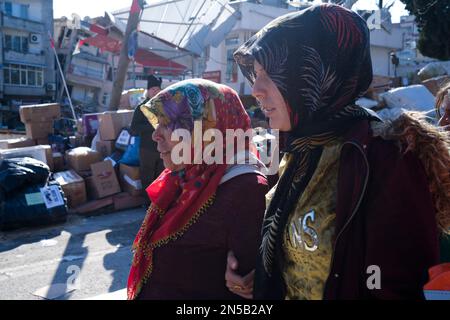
[138,173,268,300]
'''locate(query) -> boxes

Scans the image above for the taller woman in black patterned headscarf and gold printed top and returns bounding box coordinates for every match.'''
[226,4,448,299]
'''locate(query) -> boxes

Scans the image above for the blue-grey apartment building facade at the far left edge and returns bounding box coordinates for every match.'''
[0,0,56,123]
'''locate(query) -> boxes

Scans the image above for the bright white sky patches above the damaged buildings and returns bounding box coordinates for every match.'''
[53,0,408,22]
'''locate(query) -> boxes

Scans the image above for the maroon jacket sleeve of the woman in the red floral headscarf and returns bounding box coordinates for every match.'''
[227,174,268,276]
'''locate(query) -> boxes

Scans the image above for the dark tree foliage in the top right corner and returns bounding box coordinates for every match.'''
[401,0,450,60]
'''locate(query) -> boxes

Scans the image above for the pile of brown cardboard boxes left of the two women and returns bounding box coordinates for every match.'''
[0,104,147,219]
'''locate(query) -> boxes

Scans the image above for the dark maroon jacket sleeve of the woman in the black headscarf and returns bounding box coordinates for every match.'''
[362,142,439,299]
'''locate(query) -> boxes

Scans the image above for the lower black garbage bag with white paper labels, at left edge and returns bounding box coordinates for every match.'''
[0,181,68,231]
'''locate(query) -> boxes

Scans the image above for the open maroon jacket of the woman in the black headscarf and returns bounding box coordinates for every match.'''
[324,121,439,299]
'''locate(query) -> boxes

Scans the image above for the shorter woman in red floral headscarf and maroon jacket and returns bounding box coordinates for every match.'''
[128,79,268,300]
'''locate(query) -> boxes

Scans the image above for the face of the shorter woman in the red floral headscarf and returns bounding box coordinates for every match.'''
[152,122,185,171]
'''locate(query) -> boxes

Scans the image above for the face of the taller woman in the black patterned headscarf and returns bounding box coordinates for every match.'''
[252,61,292,131]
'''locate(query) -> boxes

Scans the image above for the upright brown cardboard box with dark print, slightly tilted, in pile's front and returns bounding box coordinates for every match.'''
[90,161,121,199]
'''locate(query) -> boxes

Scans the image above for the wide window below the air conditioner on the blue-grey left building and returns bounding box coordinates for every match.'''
[3,64,44,87]
